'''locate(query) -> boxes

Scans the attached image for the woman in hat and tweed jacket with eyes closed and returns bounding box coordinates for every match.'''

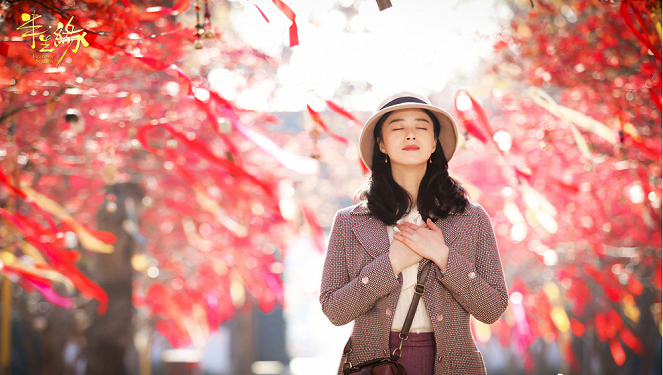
[320,92,508,375]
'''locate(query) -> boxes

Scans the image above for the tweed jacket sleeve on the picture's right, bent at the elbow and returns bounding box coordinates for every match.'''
[435,204,509,324]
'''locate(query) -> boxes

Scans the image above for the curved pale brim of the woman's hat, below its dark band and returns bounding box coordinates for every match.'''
[359,103,458,170]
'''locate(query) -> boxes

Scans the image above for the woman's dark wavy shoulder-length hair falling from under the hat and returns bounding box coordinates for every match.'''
[354,109,469,225]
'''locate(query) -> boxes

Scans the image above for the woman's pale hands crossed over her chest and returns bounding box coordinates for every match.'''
[389,219,449,276]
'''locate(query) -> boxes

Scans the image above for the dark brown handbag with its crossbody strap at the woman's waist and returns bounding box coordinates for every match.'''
[343,262,430,375]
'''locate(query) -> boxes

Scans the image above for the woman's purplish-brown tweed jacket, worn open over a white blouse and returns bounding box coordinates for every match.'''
[320,201,508,375]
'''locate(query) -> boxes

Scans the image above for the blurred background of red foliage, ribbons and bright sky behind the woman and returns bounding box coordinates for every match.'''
[0,0,662,375]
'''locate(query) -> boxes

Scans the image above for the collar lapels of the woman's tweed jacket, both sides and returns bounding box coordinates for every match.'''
[350,201,470,271]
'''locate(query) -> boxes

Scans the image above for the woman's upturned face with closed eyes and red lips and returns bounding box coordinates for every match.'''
[378,108,436,166]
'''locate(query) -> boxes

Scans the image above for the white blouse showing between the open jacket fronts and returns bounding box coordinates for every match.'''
[387,208,433,333]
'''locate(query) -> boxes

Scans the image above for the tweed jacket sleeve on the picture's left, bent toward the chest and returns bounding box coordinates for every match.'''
[320,211,401,326]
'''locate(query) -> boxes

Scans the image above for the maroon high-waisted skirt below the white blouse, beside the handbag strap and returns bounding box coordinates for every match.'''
[389,332,435,375]
